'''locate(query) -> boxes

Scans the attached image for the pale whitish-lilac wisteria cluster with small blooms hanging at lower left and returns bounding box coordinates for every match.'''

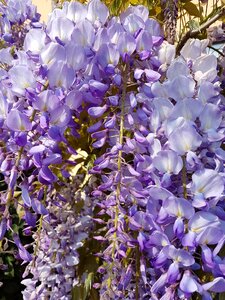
[22,175,92,300]
